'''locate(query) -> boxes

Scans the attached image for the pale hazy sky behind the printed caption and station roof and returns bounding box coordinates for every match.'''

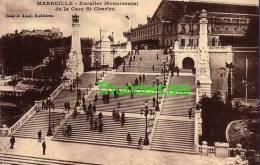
[0,0,258,42]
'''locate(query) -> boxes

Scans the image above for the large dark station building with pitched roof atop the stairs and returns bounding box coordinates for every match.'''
[124,0,258,49]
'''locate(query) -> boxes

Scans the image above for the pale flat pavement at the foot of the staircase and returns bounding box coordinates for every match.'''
[0,137,230,165]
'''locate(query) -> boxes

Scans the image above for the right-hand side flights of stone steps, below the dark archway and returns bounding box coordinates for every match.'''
[151,76,196,154]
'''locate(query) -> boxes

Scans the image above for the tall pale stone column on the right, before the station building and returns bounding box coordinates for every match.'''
[196,10,212,97]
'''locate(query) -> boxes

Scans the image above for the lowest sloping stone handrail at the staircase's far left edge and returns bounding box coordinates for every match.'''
[8,104,39,136]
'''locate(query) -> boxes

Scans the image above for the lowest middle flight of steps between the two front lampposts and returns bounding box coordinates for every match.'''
[53,113,152,148]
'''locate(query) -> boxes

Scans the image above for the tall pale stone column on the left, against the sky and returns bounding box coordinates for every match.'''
[64,14,84,79]
